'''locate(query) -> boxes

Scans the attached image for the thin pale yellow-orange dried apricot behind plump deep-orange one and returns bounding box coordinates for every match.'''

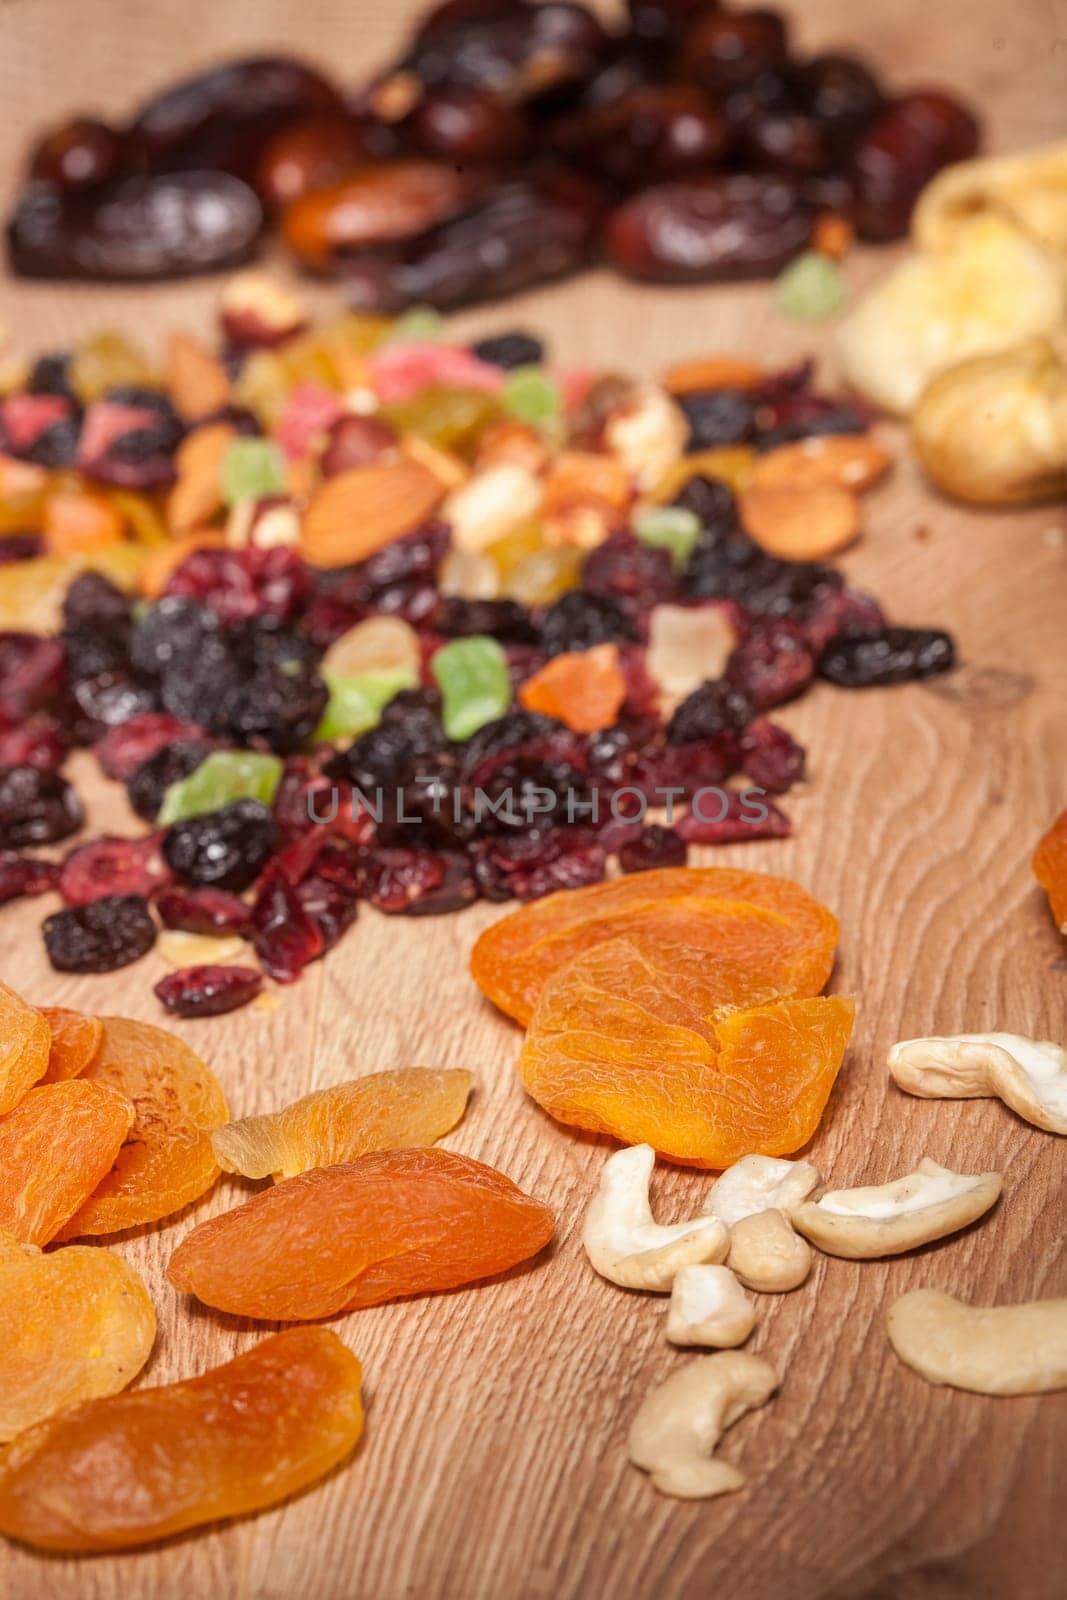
[211,1067,472,1178]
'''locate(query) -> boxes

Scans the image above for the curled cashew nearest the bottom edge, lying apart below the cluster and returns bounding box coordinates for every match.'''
[630,1350,777,1499]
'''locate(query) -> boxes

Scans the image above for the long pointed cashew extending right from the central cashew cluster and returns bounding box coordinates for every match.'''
[793,1155,1001,1261]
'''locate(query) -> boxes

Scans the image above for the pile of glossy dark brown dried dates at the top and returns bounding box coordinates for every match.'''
[8,0,979,300]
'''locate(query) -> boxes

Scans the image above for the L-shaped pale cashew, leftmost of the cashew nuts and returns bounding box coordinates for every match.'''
[582,1144,729,1293]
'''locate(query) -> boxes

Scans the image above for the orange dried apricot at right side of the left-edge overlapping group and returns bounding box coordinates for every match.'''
[61,1016,227,1238]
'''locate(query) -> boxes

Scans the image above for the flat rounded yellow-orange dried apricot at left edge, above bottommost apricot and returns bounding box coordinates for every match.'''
[0,1232,155,1443]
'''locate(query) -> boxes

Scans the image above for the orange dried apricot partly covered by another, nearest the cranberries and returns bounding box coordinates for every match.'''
[470,867,838,1022]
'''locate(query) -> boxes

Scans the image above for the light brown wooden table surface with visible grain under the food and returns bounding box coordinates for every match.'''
[0,0,1067,1600]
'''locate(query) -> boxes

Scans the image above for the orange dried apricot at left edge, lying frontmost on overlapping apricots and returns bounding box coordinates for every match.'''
[0,1078,134,1245]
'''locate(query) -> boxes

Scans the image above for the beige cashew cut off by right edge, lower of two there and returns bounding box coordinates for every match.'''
[886,1290,1067,1395]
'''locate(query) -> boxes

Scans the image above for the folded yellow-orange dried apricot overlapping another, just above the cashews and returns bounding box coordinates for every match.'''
[518,939,854,1168]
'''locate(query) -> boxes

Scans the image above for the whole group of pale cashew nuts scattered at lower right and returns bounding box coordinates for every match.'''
[582,1034,1067,1499]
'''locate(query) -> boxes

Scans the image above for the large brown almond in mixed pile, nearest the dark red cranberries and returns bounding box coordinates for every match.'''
[301,456,445,566]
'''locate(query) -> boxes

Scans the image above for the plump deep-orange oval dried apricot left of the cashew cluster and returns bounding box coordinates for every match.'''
[166,1149,555,1322]
